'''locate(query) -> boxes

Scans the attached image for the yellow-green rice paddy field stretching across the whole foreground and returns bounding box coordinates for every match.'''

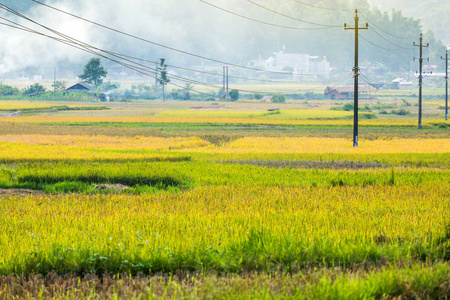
[0,99,450,299]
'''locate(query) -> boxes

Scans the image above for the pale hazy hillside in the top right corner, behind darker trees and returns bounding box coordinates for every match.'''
[370,0,450,46]
